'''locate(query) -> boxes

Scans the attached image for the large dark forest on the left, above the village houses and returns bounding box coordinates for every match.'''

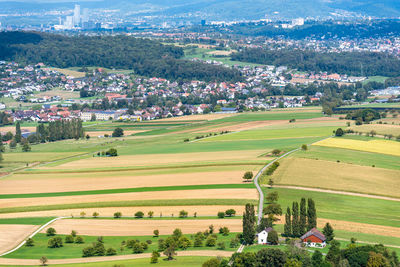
[0,32,242,81]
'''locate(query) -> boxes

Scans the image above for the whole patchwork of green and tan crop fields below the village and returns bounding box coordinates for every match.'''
[0,107,400,266]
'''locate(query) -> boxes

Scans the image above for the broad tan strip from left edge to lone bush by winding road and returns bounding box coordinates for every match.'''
[0,166,258,194]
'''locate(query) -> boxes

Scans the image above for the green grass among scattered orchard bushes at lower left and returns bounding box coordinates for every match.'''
[5,233,241,259]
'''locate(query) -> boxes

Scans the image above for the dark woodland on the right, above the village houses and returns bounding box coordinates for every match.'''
[231,48,400,77]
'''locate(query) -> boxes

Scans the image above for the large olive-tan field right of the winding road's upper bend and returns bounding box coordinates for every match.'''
[273,158,400,198]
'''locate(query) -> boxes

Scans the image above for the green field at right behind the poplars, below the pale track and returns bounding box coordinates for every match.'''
[263,187,400,227]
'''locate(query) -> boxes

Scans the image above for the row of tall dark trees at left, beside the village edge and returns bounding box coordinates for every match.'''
[34,119,85,143]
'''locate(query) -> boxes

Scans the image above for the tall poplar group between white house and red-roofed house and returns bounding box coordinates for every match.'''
[283,198,317,237]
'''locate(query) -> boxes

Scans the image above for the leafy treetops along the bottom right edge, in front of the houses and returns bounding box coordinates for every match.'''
[202,244,400,267]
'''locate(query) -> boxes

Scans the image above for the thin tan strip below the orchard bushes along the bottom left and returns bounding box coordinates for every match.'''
[0,250,234,265]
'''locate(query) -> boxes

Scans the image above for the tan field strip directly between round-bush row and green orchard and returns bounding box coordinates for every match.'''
[42,219,242,236]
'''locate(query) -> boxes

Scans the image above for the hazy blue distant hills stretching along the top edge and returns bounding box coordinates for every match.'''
[0,0,400,20]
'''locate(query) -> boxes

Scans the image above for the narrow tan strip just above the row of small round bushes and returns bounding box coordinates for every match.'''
[0,205,244,218]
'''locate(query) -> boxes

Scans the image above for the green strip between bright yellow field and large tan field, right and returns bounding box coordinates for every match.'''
[291,146,400,170]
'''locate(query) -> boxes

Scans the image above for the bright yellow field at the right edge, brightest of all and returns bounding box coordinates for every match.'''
[314,138,400,156]
